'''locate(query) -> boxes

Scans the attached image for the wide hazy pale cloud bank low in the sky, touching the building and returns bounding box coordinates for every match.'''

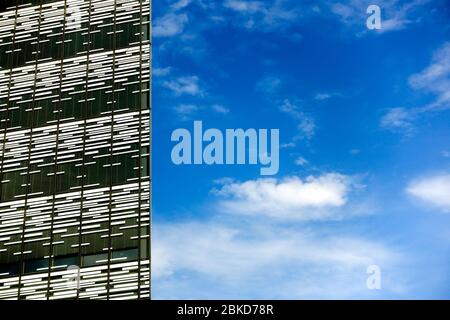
[152,220,402,299]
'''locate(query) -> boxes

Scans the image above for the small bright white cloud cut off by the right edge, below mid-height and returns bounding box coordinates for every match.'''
[407,174,450,212]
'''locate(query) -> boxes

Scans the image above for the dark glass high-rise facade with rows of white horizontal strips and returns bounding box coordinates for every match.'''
[0,0,151,299]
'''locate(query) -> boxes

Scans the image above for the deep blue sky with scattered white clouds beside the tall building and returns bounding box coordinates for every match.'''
[152,0,450,299]
